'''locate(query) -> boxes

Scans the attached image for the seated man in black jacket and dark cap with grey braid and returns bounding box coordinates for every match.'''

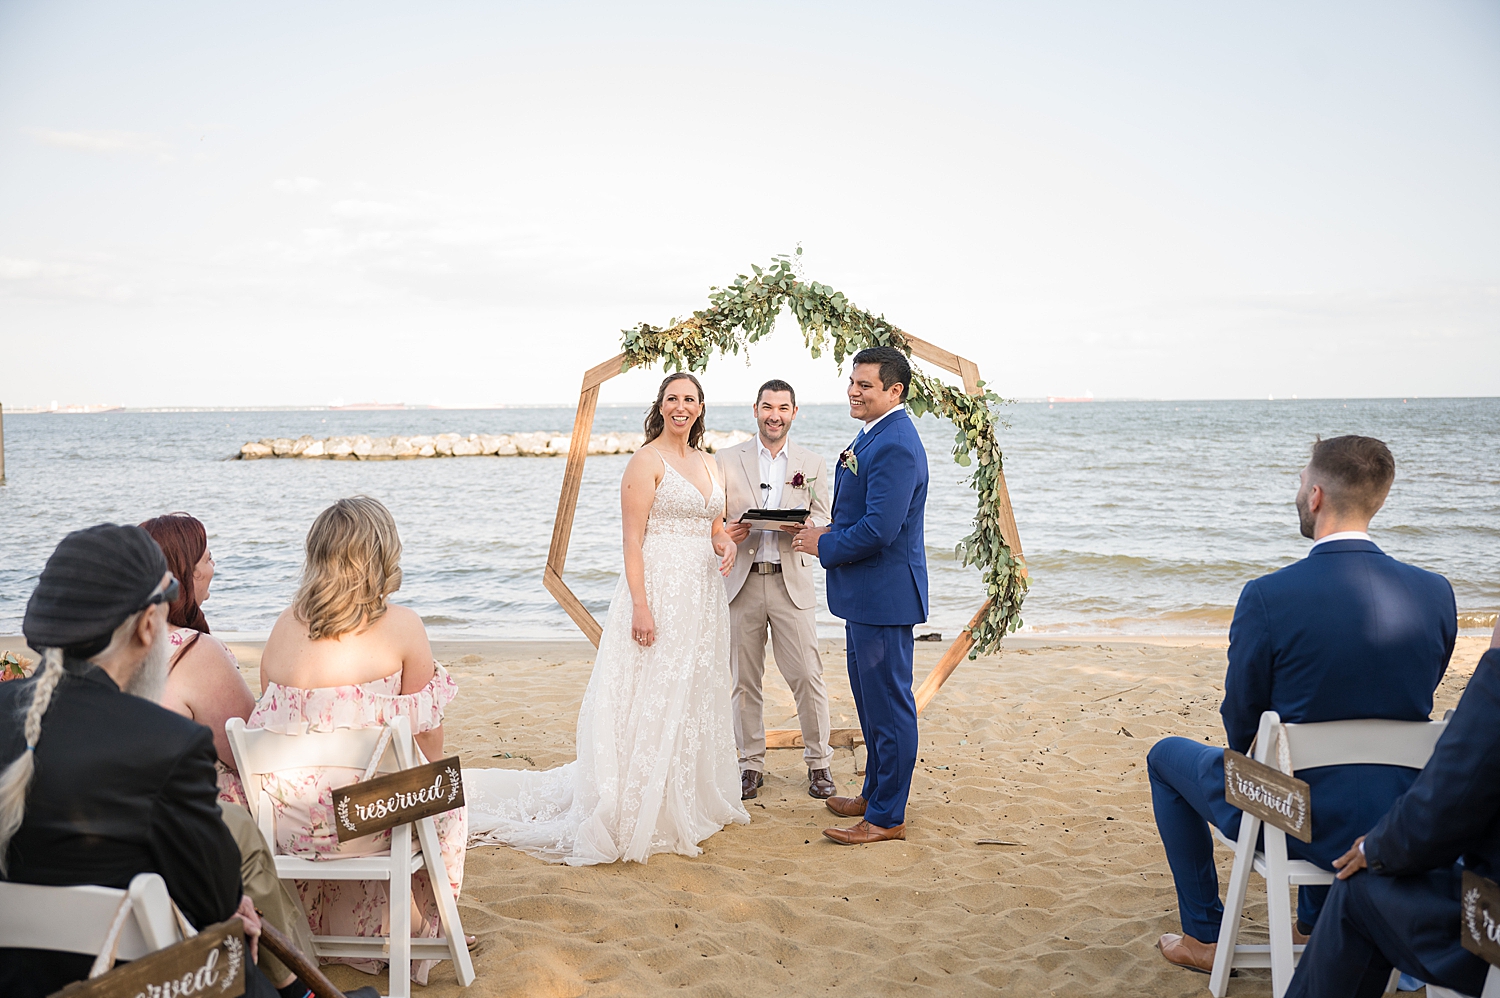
[0,524,276,998]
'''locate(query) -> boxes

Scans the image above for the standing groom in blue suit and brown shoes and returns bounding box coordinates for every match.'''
[792,347,927,845]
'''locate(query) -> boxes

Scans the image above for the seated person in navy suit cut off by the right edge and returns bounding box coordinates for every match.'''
[1287,624,1500,998]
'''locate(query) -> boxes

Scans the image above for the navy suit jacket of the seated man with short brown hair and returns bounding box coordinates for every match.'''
[1220,539,1458,869]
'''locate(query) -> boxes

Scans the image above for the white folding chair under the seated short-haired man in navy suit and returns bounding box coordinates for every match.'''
[1209,710,1452,998]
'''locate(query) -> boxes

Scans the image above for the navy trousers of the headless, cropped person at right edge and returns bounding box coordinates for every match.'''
[1287,866,1490,998]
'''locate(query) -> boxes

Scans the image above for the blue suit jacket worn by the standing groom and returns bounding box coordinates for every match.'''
[818,408,927,626]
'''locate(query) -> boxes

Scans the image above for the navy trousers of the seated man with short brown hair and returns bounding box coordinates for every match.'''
[1146,738,1328,942]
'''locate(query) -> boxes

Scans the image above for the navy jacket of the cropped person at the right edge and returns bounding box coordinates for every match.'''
[1365,648,1500,879]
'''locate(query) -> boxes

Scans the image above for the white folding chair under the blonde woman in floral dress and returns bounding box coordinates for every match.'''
[225,717,474,998]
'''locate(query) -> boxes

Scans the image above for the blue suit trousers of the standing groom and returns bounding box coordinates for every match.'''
[845,621,917,828]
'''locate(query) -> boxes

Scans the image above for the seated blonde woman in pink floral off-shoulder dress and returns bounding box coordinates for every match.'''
[249,497,468,984]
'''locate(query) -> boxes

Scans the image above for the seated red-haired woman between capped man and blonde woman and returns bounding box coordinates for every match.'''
[141,513,255,806]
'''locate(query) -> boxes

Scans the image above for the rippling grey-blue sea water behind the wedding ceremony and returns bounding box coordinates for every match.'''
[0,396,1500,639]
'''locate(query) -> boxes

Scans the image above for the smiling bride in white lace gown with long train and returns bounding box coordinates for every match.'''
[464,374,750,866]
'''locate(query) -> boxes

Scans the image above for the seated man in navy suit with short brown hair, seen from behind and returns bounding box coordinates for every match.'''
[1146,437,1458,971]
